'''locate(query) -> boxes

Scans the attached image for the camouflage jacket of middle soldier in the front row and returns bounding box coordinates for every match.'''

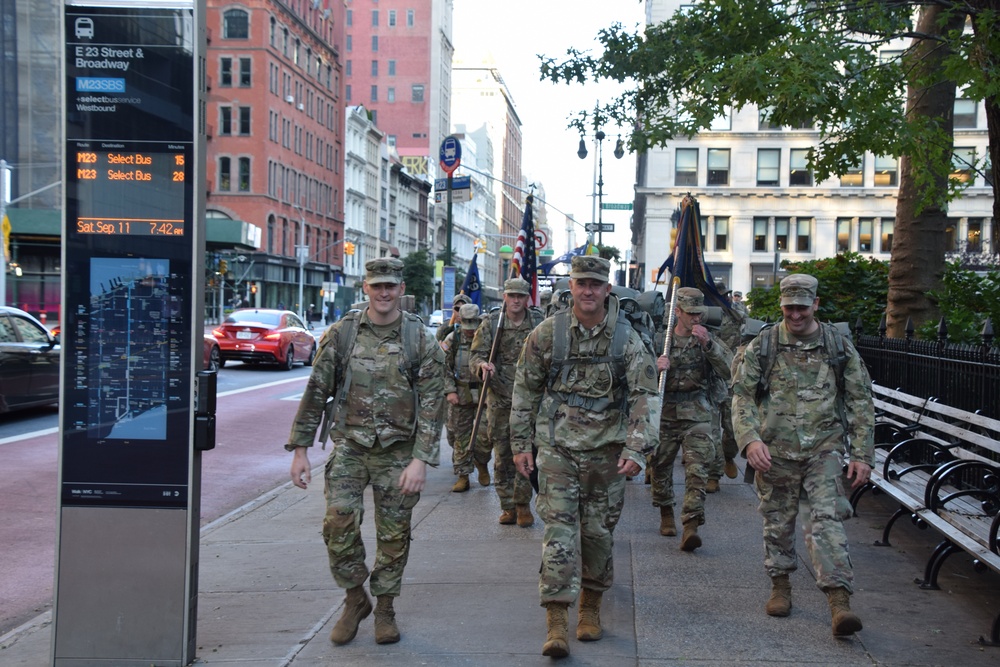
[510,313,660,467]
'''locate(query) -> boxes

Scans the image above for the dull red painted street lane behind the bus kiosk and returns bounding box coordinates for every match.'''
[0,377,307,636]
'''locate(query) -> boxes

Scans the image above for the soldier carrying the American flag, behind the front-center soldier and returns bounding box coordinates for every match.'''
[469,278,536,527]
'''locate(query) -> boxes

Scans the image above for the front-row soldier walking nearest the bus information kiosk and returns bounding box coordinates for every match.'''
[285,258,444,644]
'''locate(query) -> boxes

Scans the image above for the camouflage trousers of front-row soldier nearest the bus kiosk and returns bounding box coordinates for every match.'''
[323,439,420,597]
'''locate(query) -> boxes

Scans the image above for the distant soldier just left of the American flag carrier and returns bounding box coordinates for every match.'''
[441,303,492,493]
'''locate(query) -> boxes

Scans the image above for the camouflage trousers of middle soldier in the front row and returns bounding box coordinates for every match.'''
[535,444,625,606]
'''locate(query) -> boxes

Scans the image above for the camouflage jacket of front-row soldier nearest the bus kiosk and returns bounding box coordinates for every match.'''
[285,309,444,465]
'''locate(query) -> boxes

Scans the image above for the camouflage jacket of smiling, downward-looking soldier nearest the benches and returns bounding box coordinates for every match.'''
[733,322,875,465]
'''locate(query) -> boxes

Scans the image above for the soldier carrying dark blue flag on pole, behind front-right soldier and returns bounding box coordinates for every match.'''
[650,287,733,551]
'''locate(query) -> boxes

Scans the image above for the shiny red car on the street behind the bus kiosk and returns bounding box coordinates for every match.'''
[212,308,316,370]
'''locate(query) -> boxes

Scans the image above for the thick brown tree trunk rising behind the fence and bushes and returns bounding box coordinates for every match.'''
[886,5,965,338]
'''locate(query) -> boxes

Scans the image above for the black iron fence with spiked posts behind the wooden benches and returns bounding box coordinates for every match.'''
[854,320,1000,419]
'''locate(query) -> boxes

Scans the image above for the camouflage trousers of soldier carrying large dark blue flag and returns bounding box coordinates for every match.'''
[649,412,719,524]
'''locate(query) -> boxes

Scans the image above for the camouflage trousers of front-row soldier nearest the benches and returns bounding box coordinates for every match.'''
[754,452,854,592]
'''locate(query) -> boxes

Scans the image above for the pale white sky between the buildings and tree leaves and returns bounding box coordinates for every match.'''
[453,0,645,259]
